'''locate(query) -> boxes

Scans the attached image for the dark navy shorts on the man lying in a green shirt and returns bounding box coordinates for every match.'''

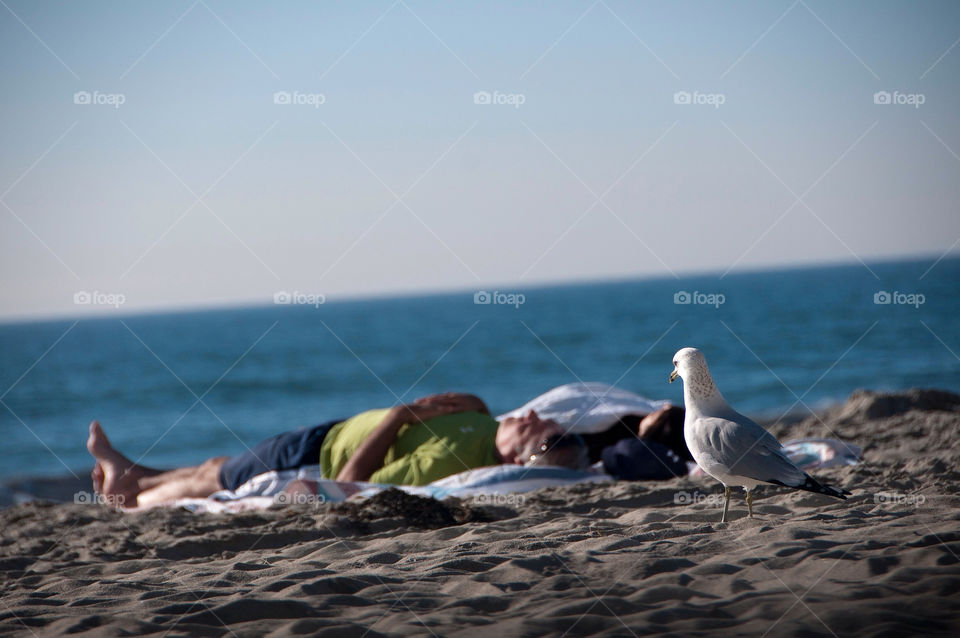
[220,419,343,491]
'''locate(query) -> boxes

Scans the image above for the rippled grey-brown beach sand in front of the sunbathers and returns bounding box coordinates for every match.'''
[0,391,960,636]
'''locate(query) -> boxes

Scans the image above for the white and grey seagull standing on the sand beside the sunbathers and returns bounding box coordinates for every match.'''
[668,348,850,523]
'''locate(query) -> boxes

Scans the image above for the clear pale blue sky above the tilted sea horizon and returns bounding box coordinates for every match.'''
[0,0,960,319]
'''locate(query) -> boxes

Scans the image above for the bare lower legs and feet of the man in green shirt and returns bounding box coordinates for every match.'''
[87,421,227,507]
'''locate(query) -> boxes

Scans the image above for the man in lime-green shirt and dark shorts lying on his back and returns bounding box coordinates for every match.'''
[87,392,563,507]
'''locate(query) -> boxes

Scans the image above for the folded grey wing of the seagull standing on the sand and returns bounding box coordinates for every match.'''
[697,412,807,487]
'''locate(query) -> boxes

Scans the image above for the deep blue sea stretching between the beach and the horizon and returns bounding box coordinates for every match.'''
[0,257,960,480]
